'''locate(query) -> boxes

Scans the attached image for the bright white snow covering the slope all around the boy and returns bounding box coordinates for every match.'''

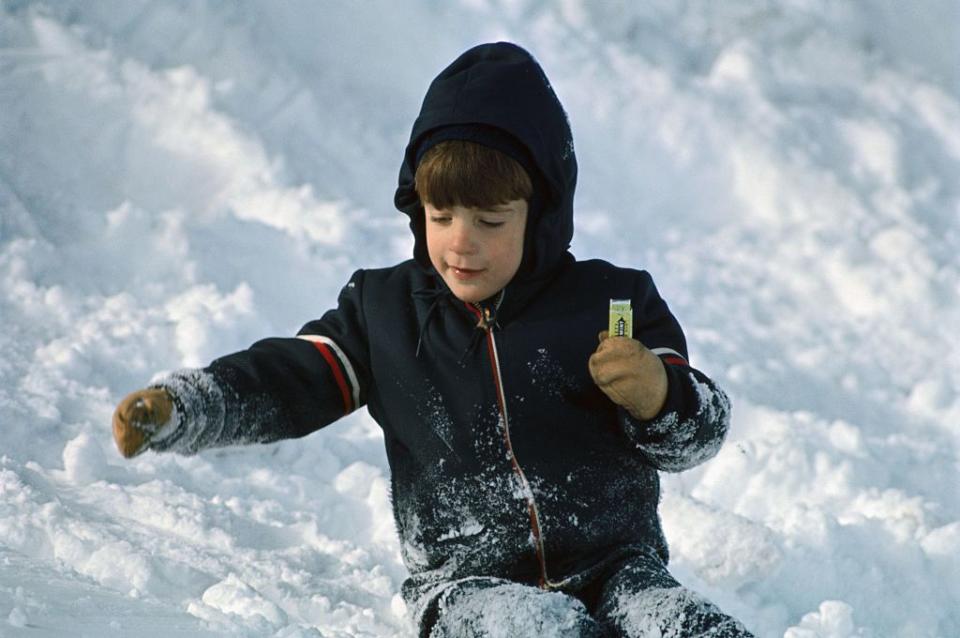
[0,0,960,638]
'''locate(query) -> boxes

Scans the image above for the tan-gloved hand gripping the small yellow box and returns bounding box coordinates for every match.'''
[588,330,667,420]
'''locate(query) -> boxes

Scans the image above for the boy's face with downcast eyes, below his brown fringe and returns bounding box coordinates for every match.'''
[424,199,527,303]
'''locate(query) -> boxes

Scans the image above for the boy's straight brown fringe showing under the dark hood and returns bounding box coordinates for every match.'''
[414,140,533,209]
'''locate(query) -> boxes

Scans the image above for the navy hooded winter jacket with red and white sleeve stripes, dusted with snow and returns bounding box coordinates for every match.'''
[152,43,729,612]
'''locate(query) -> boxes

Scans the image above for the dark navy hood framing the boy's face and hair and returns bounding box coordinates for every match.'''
[394,42,577,281]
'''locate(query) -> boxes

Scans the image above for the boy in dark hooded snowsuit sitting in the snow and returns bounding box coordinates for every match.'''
[113,43,750,637]
